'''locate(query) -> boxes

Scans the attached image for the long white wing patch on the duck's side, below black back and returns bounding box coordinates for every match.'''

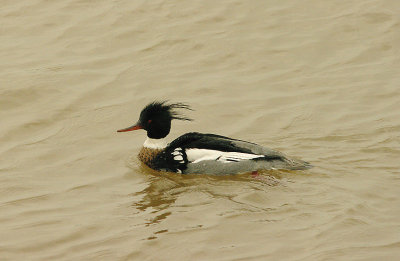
[186,149,264,163]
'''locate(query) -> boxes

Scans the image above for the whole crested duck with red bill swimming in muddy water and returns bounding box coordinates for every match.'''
[118,102,312,175]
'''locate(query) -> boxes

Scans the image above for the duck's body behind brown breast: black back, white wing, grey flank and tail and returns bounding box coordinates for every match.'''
[152,132,307,174]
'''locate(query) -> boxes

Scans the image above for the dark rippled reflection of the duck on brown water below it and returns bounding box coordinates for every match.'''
[132,161,284,226]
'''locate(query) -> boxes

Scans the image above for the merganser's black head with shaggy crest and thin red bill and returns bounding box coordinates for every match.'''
[118,101,192,139]
